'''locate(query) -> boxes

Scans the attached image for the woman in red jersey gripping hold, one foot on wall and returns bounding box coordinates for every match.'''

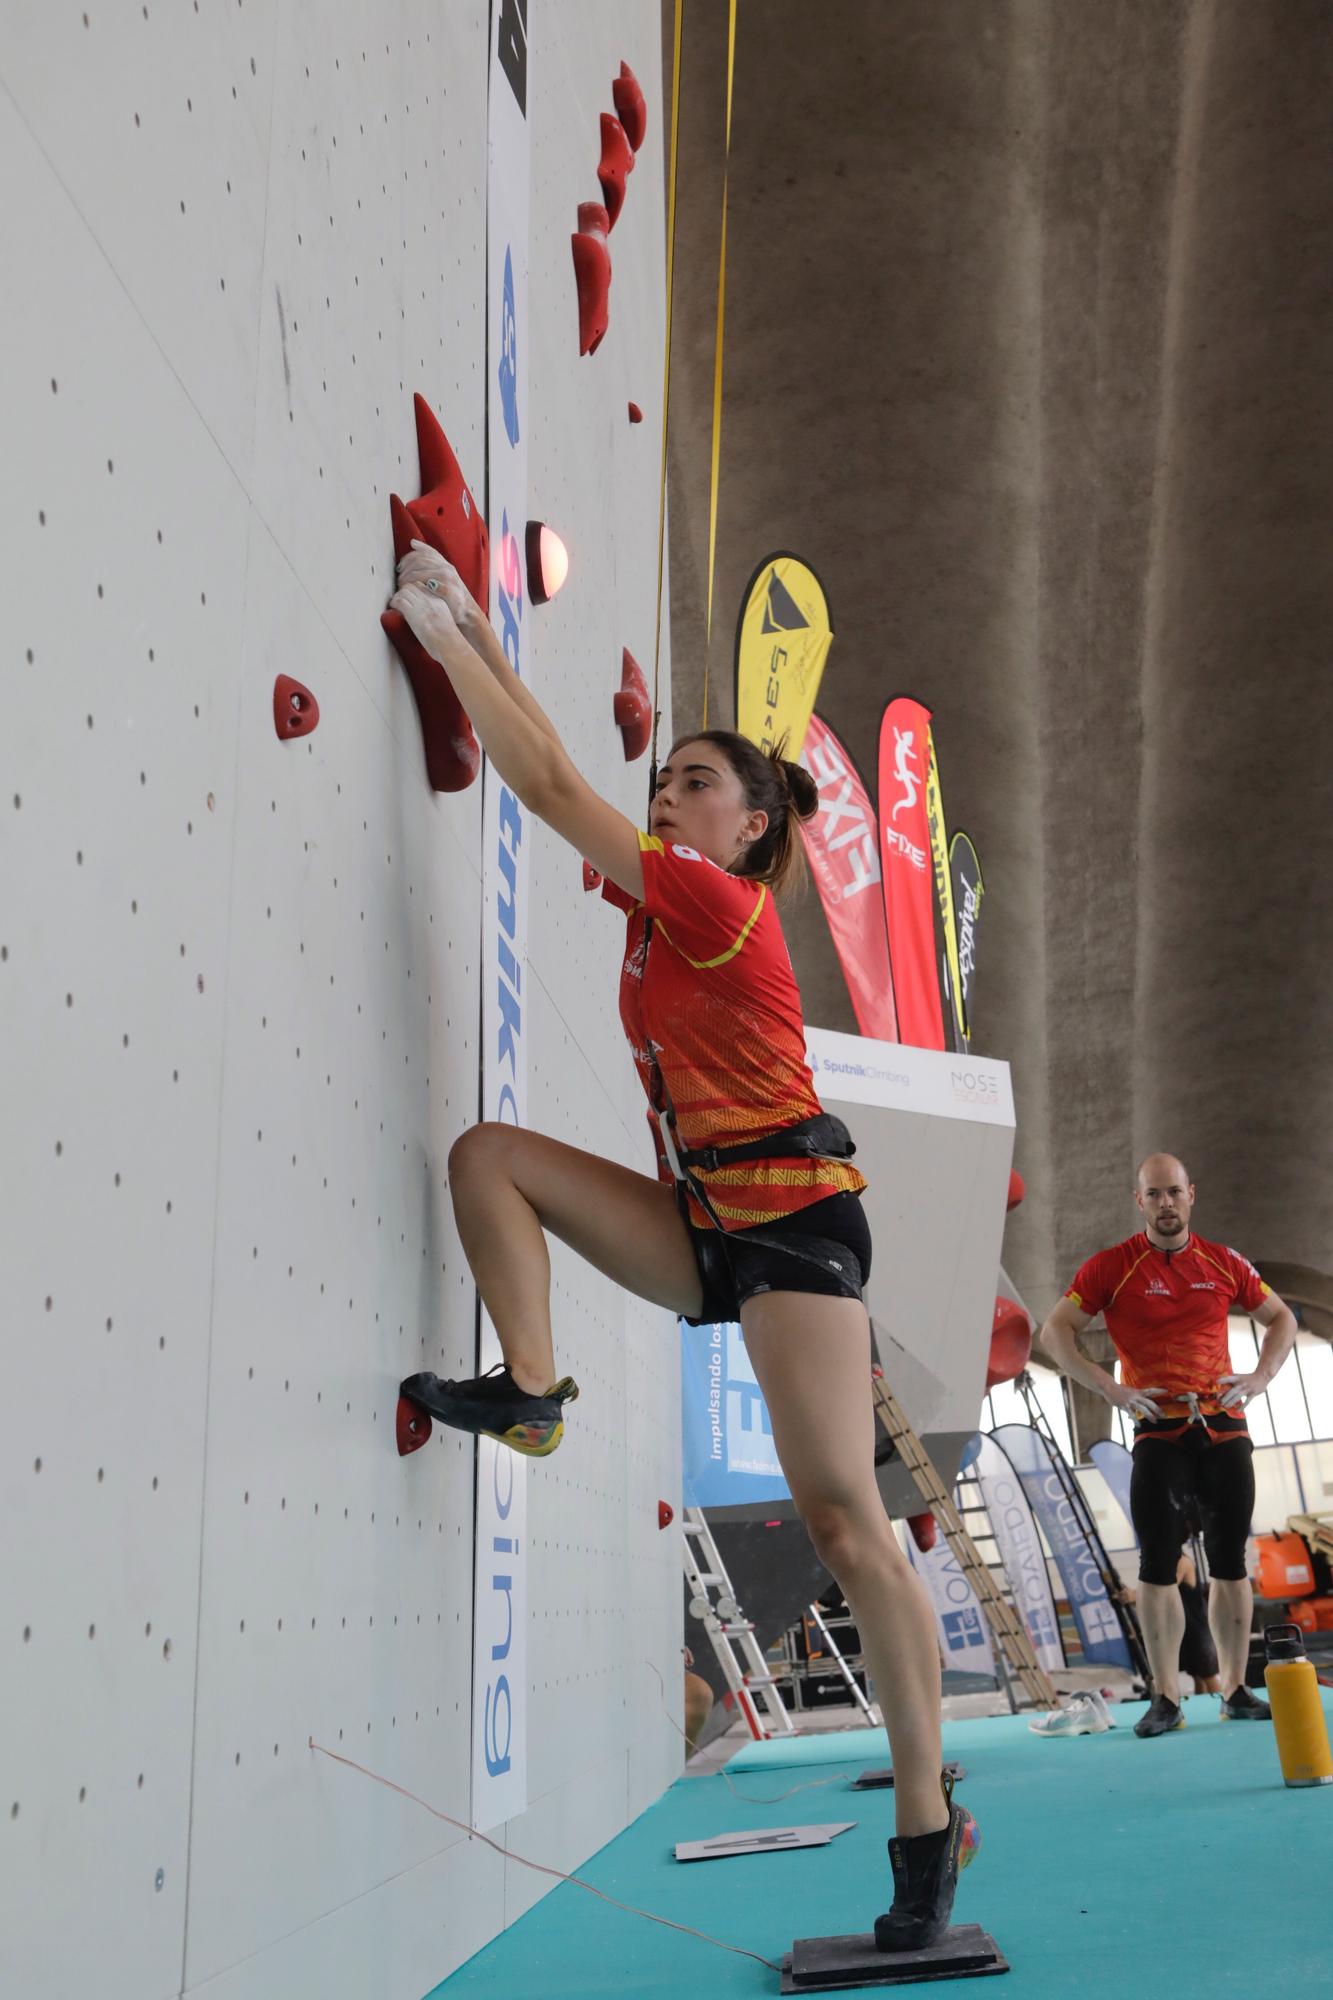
[392,542,979,1950]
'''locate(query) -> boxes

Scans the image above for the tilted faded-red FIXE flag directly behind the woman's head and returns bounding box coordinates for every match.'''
[801,716,899,1042]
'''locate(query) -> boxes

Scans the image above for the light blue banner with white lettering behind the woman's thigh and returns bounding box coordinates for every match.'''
[681,1320,791,1506]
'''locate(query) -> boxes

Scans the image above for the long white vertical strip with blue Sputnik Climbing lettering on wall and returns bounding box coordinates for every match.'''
[472,0,530,1832]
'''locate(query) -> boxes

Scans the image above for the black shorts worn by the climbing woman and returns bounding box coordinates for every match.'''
[677,1190,871,1326]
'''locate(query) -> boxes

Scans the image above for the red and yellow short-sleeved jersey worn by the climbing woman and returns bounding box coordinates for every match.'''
[602,832,867,1230]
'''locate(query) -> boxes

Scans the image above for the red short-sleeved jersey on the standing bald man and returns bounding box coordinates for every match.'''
[1065,1230,1269,1404]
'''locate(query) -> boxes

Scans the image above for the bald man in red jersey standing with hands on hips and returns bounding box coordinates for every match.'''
[1041,1152,1295,1736]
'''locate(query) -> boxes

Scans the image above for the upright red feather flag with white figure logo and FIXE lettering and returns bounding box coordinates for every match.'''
[879,694,945,1050]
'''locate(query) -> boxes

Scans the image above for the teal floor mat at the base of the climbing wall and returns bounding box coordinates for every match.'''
[436,1692,1333,2000]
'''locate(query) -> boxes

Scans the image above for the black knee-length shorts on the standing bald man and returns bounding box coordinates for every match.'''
[1129,1424,1255,1584]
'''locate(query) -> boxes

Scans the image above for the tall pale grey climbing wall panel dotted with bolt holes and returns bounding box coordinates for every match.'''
[0,0,681,2000]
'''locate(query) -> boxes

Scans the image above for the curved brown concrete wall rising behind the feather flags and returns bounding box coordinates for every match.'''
[662,0,1333,1320]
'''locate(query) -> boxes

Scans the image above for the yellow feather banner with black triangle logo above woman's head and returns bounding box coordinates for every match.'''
[737,552,833,760]
